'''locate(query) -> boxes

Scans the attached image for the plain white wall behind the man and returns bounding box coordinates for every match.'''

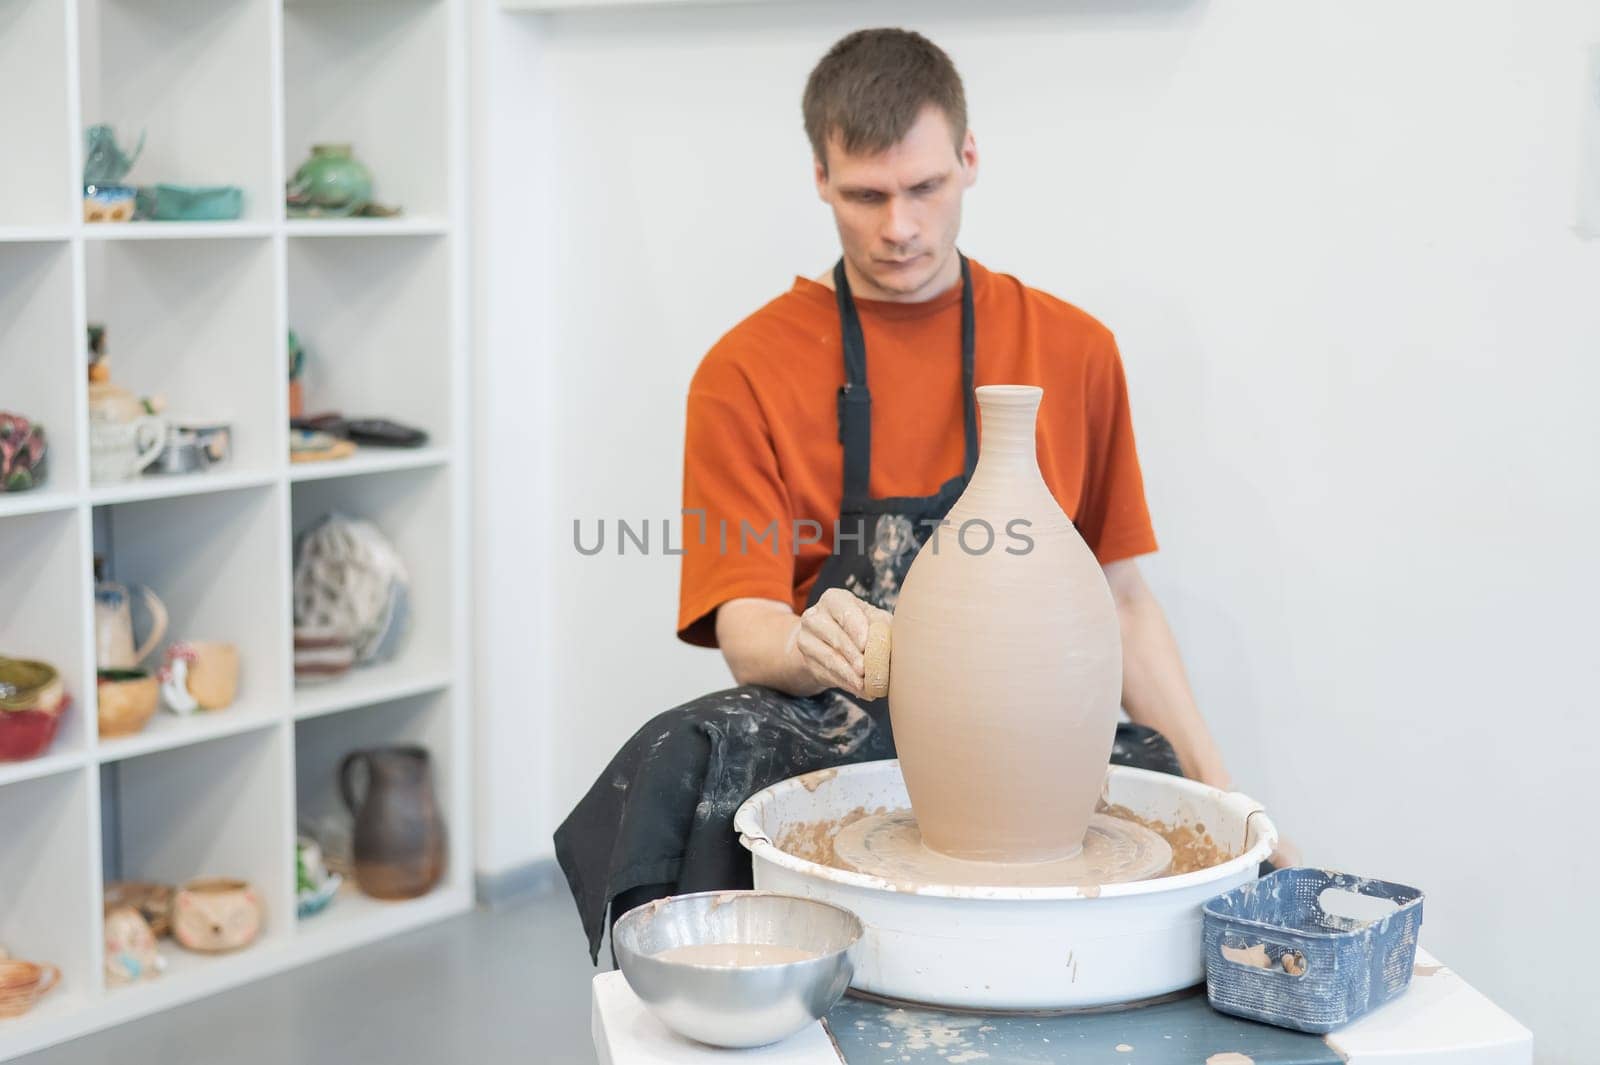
[478,0,1600,1062]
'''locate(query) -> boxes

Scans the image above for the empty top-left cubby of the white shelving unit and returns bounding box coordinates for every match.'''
[0,0,77,223]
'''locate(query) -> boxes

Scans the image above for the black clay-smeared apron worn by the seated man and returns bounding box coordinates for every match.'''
[555,256,1178,959]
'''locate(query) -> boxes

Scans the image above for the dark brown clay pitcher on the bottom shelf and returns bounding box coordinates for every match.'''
[339,747,445,899]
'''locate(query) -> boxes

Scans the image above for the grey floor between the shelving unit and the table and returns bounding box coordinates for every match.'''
[16,891,595,1065]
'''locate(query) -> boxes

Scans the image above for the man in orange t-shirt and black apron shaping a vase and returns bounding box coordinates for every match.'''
[555,29,1248,953]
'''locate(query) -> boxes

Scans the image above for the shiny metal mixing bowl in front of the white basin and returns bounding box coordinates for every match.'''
[611,891,862,1047]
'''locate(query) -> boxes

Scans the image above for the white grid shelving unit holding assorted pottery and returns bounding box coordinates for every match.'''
[0,0,472,1060]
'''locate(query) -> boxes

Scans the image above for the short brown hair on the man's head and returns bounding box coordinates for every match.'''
[800,29,966,171]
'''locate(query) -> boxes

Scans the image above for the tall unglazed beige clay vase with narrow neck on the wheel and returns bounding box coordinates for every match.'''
[890,385,1122,862]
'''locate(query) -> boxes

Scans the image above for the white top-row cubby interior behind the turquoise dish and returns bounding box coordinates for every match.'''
[78,0,282,221]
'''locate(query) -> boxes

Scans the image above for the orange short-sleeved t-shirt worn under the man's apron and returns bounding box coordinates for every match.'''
[678,262,1155,648]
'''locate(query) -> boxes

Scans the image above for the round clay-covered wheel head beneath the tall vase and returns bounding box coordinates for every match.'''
[834,809,1173,888]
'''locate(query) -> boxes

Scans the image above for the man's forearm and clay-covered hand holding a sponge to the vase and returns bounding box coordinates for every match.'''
[717,588,891,696]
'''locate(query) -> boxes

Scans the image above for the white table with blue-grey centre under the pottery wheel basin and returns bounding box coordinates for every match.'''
[594,951,1533,1065]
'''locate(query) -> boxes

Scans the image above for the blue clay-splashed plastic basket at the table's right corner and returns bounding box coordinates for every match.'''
[1203,868,1422,1035]
